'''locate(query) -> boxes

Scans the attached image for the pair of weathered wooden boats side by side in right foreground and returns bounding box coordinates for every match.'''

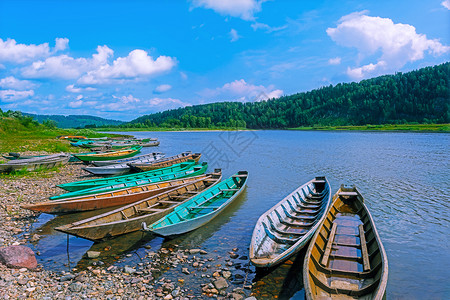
[250,177,388,299]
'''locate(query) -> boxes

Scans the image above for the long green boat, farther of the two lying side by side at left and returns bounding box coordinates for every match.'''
[58,160,200,192]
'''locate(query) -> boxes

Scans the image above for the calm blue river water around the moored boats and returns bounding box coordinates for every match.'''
[28,131,450,299]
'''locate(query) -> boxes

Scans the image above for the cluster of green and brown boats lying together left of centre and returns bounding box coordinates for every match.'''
[22,152,248,241]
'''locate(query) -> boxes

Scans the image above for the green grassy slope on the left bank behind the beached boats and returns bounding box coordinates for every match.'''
[0,109,118,153]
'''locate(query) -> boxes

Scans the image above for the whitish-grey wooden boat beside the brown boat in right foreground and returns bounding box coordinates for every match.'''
[250,177,331,267]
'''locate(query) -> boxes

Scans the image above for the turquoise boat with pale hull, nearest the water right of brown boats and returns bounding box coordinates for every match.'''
[142,171,248,236]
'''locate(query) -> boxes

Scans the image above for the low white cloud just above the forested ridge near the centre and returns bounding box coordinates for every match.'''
[200,79,283,101]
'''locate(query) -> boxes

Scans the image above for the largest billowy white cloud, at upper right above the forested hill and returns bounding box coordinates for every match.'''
[327,11,450,79]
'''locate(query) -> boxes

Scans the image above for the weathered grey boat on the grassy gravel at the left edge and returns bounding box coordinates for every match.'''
[0,153,70,173]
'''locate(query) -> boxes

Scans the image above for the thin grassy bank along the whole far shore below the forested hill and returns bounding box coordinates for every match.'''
[93,124,450,133]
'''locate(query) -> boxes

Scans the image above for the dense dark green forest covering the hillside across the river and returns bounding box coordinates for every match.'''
[118,62,450,129]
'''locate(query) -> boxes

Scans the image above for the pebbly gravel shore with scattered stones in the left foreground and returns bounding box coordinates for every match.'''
[0,158,255,299]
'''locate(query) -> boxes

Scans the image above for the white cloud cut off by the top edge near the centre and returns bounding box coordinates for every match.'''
[192,0,262,21]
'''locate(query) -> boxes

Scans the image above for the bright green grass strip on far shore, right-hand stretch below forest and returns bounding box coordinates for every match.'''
[289,124,450,132]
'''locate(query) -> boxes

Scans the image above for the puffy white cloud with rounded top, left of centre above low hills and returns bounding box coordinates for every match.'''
[77,49,177,85]
